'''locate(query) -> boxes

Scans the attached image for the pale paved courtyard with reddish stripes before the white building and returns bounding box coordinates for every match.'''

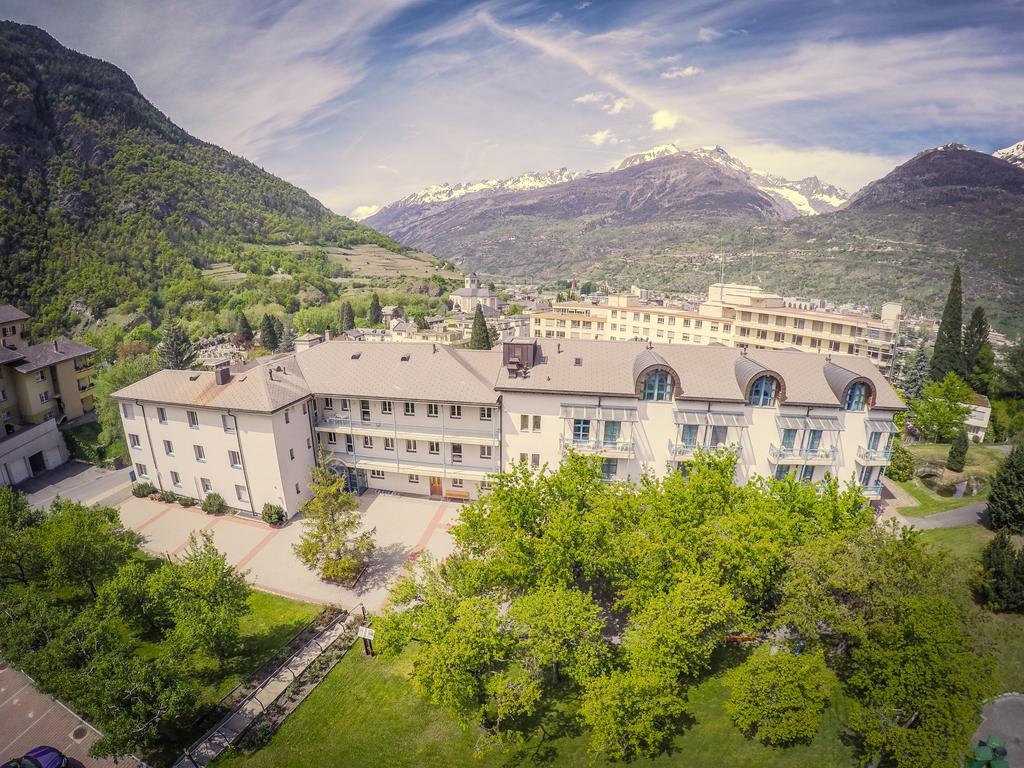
[119,492,460,611]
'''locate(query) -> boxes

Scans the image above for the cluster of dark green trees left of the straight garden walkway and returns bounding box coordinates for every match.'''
[0,487,249,757]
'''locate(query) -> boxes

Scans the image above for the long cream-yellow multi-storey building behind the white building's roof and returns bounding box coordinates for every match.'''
[529,283,901,377]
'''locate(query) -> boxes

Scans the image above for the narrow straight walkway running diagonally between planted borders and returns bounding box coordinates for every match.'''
[174,613,351,768]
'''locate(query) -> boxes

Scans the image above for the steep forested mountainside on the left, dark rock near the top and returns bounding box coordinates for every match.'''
[0,22,403,334]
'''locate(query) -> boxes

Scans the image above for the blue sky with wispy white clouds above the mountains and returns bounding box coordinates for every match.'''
[0,0,1024,214]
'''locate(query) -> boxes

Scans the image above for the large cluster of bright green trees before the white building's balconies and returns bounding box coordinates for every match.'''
[376,452,992,768]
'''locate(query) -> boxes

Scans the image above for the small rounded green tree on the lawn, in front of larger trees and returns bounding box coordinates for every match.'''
[725,645,831,745]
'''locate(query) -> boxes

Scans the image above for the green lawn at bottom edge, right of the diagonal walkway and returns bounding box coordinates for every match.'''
[216,645,855,768]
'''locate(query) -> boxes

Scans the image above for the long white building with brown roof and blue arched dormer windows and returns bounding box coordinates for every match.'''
[114,338,903,515]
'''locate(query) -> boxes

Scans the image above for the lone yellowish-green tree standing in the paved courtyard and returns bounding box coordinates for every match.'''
[294,452,377,582]
